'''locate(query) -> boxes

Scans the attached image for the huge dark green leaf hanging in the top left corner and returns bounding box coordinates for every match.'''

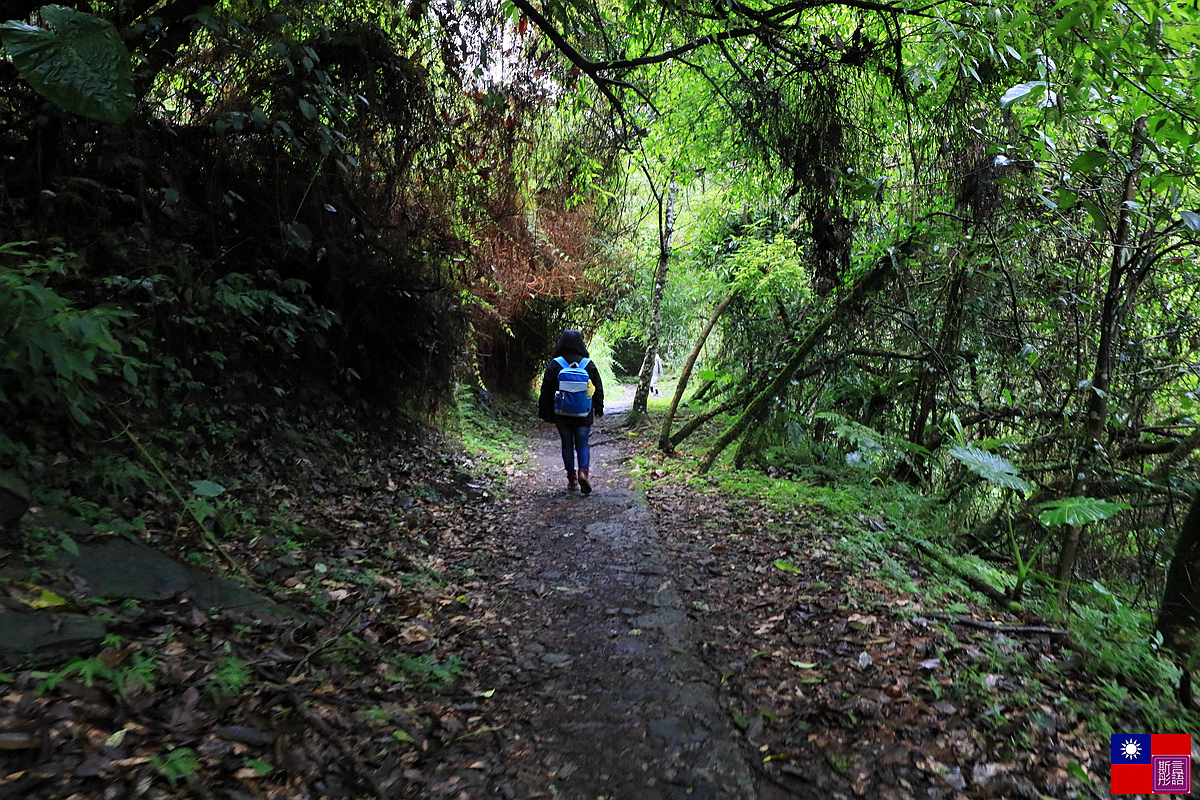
[0,6,134,122]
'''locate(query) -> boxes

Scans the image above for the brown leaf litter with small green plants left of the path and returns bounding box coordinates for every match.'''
[0,419,513,800]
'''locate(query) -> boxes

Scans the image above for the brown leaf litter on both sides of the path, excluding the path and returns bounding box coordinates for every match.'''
[0,410,1106,800]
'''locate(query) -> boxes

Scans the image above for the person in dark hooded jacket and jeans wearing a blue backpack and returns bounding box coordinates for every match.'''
[538,330,604,494]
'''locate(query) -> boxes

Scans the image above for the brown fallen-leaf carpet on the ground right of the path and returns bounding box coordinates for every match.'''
[647,460,1108,798]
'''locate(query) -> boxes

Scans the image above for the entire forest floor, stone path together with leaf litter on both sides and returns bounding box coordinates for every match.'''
[0,392,1108,800]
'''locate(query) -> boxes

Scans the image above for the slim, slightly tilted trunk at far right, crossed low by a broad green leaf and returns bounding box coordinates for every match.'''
[1055,116,1146,603]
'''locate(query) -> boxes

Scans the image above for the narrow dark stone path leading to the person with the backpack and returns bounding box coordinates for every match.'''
[441,414,760,800]
